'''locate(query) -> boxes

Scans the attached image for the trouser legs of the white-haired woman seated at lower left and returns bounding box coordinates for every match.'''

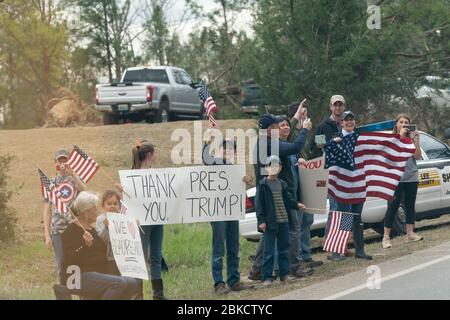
[74,272,138,300]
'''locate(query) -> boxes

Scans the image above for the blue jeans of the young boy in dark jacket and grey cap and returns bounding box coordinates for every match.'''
[262,222,289,280]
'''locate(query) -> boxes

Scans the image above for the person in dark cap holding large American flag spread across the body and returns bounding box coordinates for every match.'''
[324,111,416,261]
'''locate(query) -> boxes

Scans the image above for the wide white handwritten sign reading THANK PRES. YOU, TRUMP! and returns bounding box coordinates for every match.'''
[119,165,245,225]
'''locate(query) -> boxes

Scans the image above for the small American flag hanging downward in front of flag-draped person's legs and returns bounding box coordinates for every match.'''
[323,211,353,254]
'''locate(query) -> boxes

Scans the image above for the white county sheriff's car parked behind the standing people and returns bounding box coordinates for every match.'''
[239,129,450,241]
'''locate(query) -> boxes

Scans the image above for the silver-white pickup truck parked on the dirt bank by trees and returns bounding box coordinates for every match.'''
[95,66,204,124]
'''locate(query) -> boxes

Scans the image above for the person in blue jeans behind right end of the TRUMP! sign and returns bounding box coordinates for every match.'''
[203,138,254,294]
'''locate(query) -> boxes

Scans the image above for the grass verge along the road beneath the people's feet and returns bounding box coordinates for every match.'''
[0,215,450,300]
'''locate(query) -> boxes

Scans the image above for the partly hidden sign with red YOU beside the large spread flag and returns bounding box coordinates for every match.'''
[298,157,328,214]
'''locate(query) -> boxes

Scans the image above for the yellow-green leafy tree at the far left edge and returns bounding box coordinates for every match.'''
[0,0,67,127]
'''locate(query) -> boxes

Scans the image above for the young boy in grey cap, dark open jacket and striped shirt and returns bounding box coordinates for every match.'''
[256,155,305,286]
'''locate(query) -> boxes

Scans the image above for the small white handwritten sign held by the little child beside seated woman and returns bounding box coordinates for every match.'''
[107,213,148,280]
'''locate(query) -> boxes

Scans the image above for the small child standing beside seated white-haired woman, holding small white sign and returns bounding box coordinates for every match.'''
[95,190,120,276]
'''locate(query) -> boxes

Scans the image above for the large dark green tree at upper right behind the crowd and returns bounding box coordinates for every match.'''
[254,0,449,122]
